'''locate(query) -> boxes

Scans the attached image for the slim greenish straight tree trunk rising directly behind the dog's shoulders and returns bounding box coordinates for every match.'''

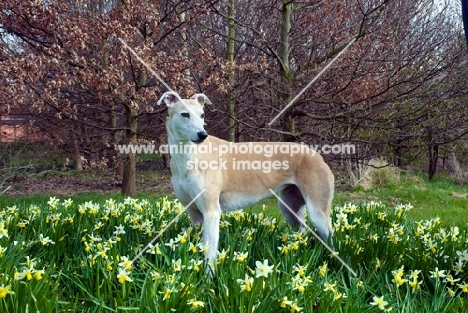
[226,0,236,142]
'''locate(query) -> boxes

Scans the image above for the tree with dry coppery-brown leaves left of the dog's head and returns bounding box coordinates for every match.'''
[0,0,198,196]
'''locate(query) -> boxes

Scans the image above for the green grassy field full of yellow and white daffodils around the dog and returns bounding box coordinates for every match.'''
[0,175,468,312]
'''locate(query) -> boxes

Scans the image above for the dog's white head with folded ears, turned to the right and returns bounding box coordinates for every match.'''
[157,91,211,143]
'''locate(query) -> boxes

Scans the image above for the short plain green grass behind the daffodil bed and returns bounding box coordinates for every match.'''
[0,171,468,226]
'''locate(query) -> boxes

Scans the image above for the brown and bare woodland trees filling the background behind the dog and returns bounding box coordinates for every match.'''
[0,0,468,195]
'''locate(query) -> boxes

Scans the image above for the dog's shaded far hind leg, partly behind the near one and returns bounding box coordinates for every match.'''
[278,185,305,228]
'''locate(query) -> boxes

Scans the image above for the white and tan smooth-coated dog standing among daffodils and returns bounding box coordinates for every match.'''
[157,92,334,262]
